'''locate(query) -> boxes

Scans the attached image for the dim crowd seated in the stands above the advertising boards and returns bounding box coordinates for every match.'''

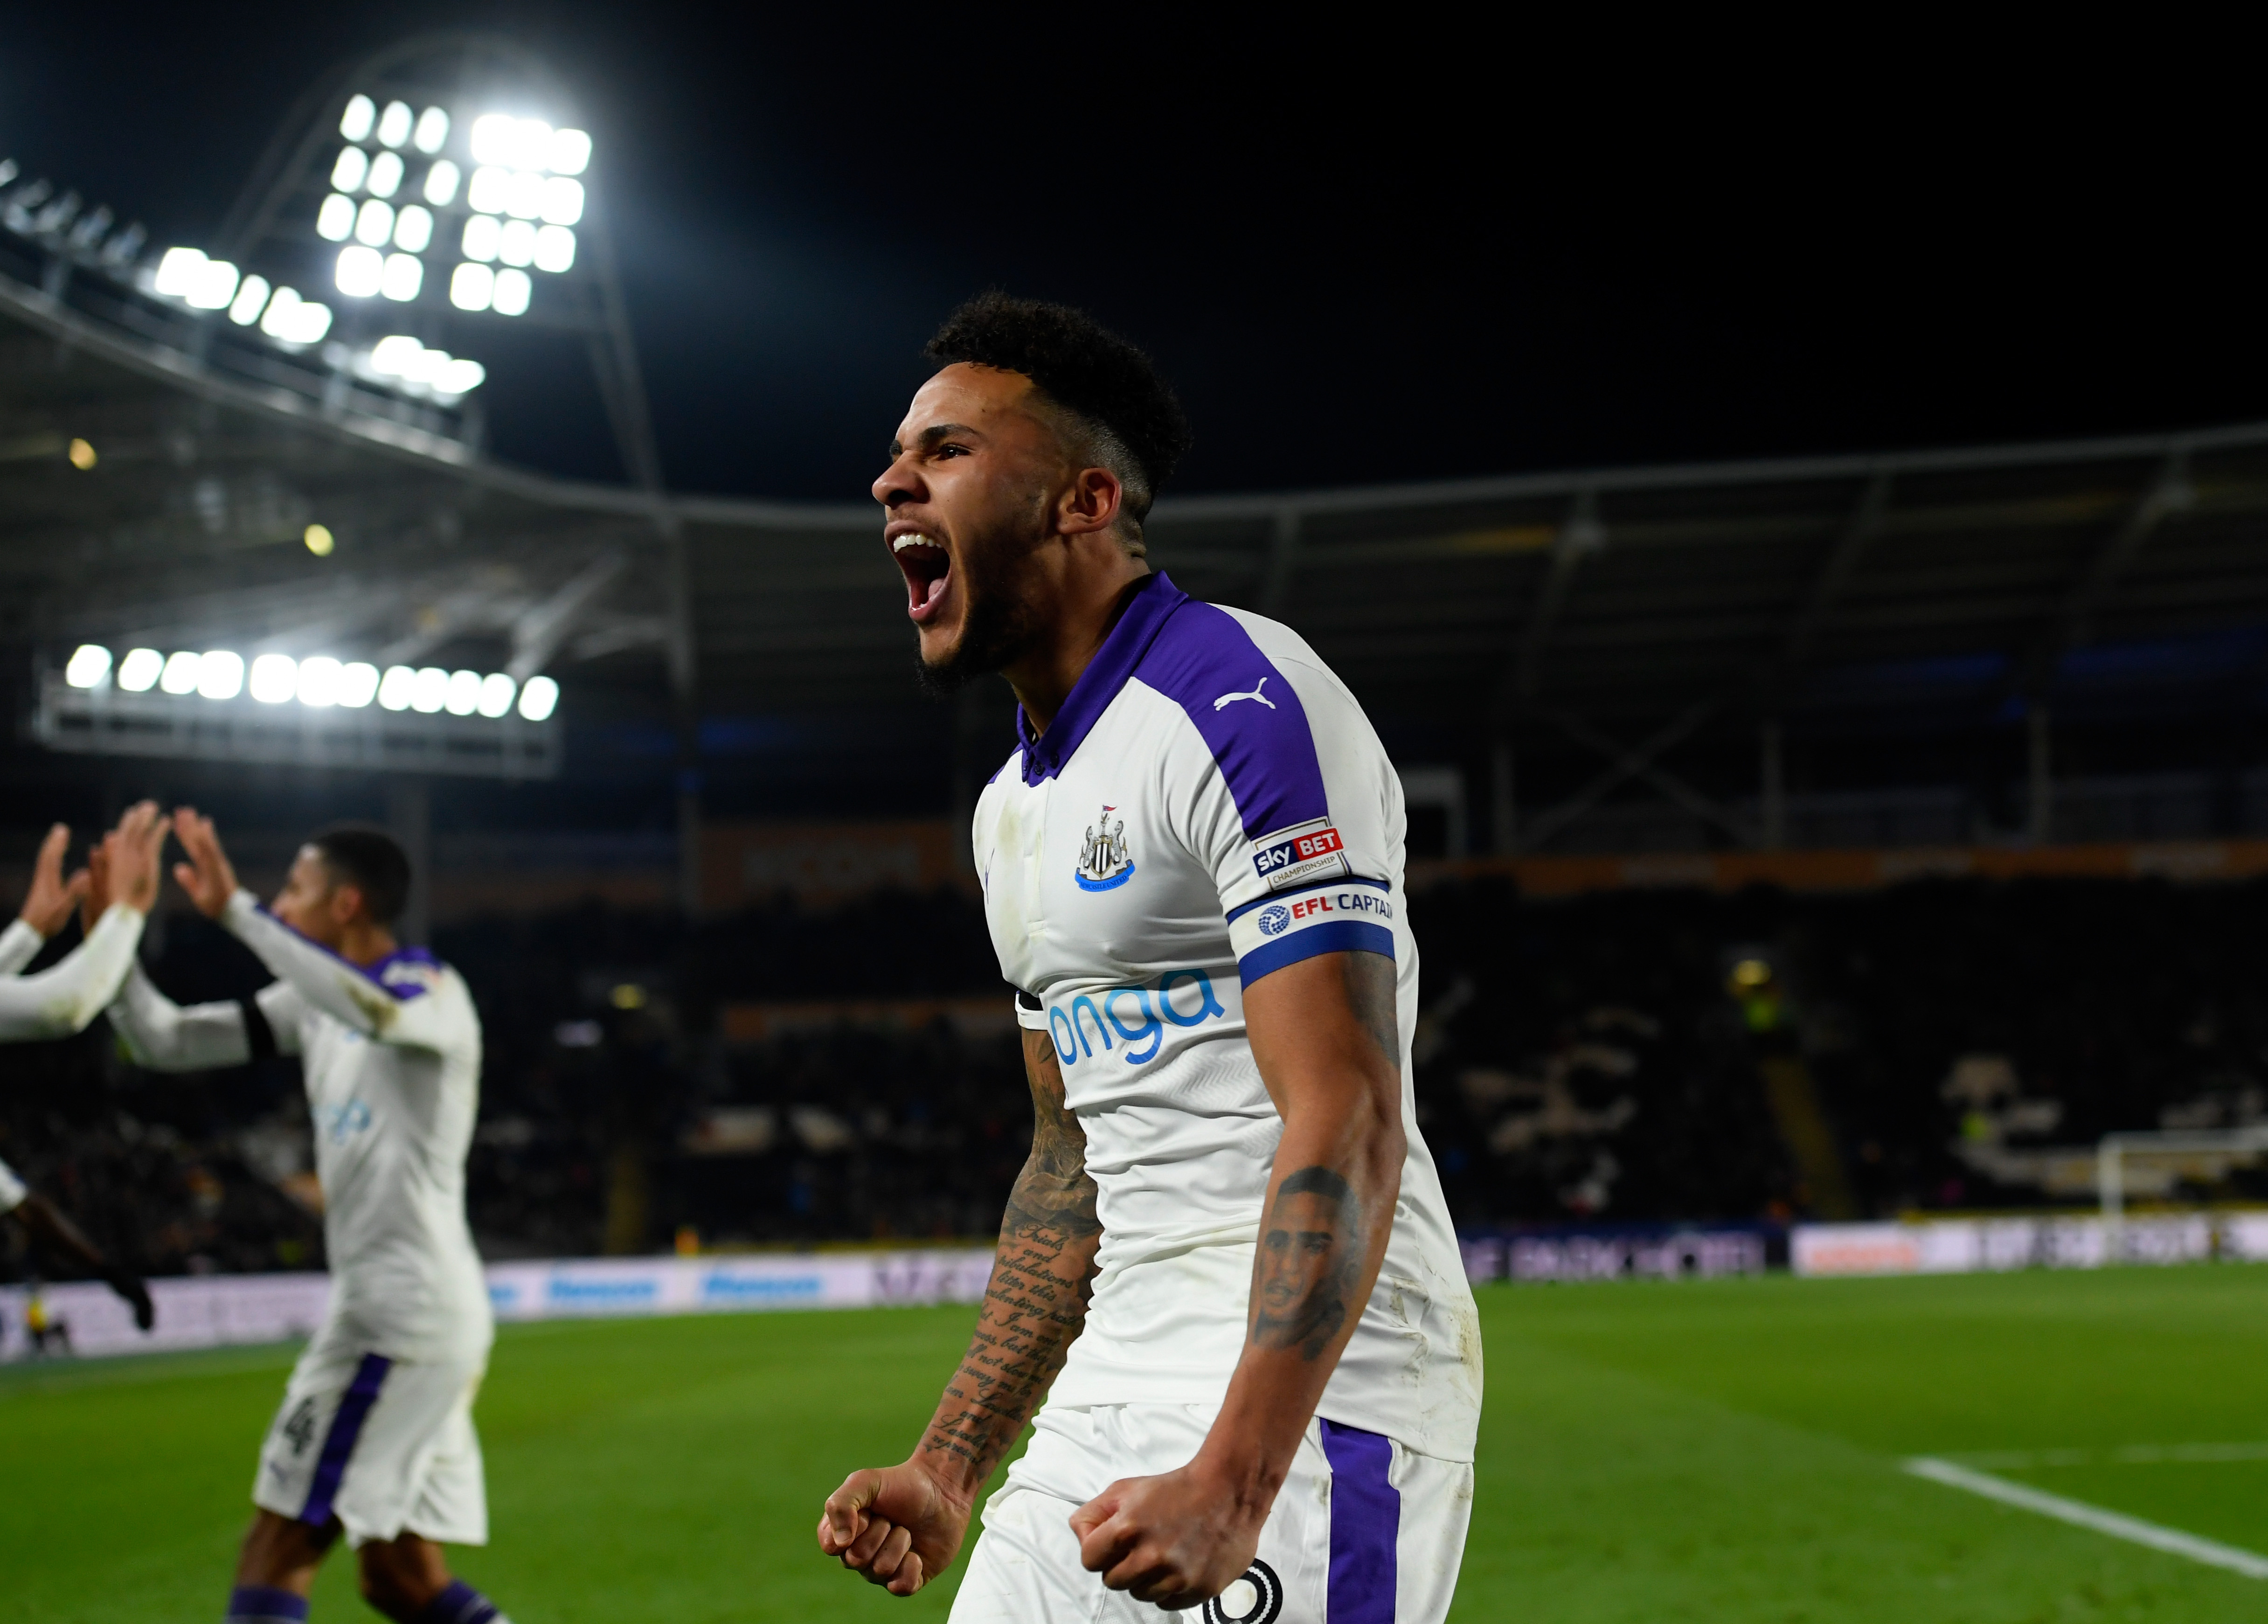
[13,880,2268,1277]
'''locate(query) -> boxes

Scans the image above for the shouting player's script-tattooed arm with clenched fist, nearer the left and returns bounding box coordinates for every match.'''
[819,1032,1102,1597]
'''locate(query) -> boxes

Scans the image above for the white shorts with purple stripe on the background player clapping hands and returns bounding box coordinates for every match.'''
[252,1338,488,1547]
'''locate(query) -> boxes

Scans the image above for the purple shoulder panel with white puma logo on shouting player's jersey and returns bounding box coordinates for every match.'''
[1134,599,1332,839]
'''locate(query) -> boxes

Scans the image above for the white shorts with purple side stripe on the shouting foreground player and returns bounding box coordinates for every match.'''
[952,1404,1472,1624]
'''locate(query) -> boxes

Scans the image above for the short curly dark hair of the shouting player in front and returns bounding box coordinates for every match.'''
[928,288,1188,554]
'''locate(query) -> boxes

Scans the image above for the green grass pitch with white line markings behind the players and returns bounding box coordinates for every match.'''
[0,1266,2268,1624]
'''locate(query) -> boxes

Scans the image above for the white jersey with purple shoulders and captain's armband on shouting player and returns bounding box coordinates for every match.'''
[975,574,1481,1461]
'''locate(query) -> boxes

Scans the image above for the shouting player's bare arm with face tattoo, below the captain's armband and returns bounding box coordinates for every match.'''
[1070,953,1406,1608]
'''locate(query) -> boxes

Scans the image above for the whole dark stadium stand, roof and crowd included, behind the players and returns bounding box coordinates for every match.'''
[13,148,2268,1275]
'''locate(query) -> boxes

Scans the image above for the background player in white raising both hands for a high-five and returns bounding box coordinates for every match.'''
[91,807,501,1624]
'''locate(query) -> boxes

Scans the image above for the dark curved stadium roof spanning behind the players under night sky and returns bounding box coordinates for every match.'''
[0,219,2268,839]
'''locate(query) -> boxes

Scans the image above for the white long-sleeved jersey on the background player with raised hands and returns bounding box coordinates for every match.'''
[111,891,494,1363]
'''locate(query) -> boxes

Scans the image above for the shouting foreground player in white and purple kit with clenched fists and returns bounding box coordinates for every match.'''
[819,295,1481,1624]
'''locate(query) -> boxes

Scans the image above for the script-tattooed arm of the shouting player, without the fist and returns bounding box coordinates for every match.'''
[921,1032,1102,1483]
